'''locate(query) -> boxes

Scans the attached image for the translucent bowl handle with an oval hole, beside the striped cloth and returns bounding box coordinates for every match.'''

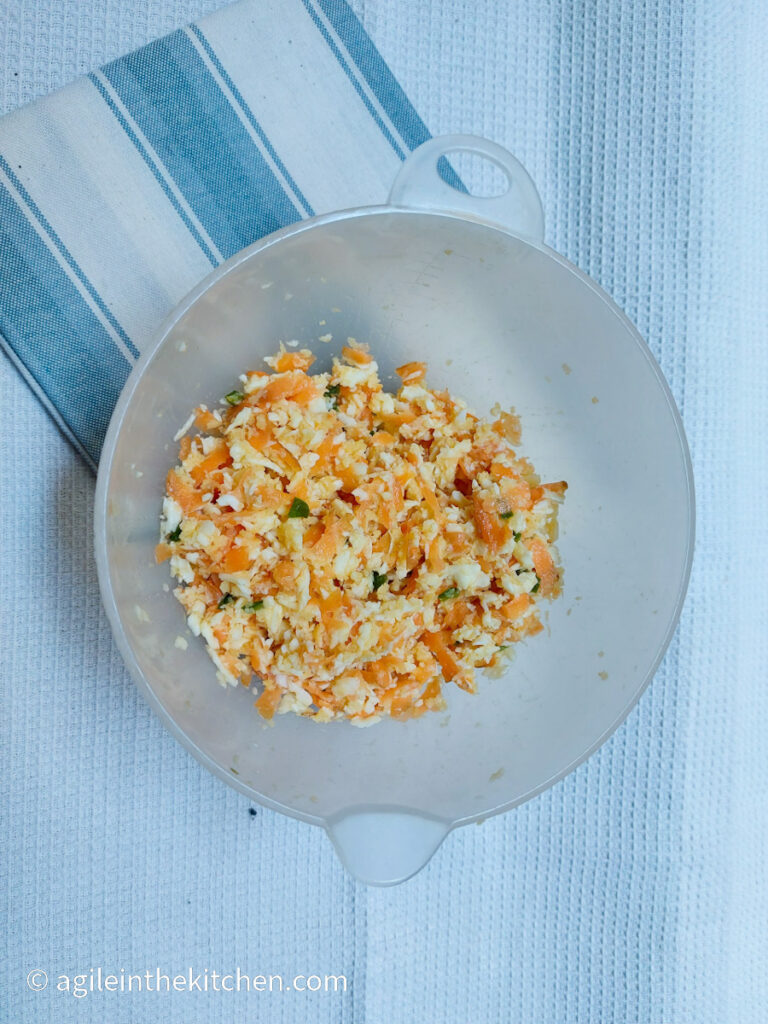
[389,135,544,243]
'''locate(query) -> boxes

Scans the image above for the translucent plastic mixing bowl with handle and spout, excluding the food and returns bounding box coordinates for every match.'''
[95,136,693,884]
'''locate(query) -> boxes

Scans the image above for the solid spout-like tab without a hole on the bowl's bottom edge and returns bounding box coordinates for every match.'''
[326,808,451,886]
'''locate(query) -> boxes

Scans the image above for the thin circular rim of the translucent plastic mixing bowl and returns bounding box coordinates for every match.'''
[93,204,696,833]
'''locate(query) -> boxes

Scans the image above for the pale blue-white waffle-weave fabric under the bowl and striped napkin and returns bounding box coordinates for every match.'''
[0,0,768,1024]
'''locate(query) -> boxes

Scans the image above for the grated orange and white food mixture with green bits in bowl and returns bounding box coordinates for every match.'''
[157,339,566,725]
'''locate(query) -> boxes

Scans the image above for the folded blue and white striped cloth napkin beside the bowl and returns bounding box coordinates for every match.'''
[0,0,429,468]
